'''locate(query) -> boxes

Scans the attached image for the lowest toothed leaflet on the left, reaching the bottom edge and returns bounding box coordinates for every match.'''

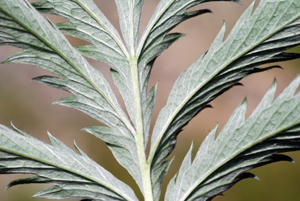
[0,125,138,201]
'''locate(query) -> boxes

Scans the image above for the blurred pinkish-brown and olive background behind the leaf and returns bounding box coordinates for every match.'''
[0,0,300,201]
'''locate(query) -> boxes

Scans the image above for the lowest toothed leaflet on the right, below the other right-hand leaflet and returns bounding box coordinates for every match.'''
[165,76,300,201]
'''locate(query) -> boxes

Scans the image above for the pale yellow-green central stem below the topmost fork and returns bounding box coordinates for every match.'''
[130,57,153,201]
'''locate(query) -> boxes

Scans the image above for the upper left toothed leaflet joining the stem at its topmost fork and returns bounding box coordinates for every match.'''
[33,0,136,129]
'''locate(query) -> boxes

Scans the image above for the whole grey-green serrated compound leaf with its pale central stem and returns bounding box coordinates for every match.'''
[0,0,300,201]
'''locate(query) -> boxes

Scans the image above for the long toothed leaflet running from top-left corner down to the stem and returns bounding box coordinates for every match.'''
[0,0,149,195]
